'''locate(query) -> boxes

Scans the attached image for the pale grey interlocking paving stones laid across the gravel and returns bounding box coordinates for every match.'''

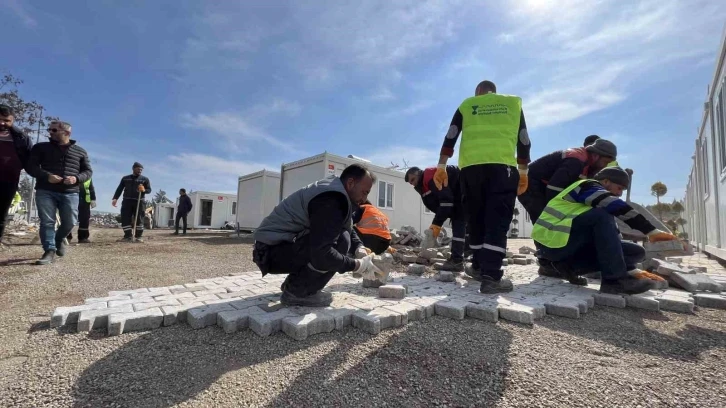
[51,258,726,340]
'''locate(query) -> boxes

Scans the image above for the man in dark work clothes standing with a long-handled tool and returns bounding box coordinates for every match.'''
[111,162,151,242]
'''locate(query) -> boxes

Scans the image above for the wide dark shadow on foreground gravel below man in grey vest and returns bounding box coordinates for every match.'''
[71,318,511,408]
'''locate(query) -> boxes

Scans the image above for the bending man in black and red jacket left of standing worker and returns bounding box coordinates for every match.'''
[405,166,466,272]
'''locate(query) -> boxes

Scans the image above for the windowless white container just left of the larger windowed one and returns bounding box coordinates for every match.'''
[236,170,280,230]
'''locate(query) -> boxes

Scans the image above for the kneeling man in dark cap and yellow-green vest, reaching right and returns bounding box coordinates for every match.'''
[532,167,677,294]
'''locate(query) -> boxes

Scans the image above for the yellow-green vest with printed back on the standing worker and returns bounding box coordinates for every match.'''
[459,93,522,169]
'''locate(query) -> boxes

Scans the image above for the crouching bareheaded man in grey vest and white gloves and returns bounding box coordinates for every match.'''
[252,164,382,307]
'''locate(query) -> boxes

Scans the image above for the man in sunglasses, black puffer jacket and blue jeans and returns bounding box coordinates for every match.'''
[26,120,93,265]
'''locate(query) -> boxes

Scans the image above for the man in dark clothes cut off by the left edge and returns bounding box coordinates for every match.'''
[0,105,33,249]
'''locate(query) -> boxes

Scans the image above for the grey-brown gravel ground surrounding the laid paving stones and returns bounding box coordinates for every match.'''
[0,230,726,407]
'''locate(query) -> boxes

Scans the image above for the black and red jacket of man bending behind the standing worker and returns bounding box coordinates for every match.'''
[415,166,464,227]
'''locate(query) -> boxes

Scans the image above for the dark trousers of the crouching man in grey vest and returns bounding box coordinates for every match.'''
[267,231,352,297]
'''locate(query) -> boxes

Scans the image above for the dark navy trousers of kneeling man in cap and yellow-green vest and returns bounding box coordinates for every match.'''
[540,208,645,280]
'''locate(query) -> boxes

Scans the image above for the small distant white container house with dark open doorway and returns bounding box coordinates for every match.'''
[187,191,237,229]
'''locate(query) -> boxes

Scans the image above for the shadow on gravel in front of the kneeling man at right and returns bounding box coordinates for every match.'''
[537,308,726,361]
